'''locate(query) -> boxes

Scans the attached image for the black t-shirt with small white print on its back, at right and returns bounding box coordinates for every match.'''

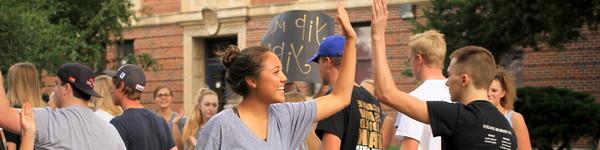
[427,100,517,150]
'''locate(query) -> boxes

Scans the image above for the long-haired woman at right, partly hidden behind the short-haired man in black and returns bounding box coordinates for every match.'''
[488,69,531,150]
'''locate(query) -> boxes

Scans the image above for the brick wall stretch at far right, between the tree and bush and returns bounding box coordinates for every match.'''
[521,29,600,100]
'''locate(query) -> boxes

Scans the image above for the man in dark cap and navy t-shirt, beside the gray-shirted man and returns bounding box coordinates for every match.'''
[105,64,177,150]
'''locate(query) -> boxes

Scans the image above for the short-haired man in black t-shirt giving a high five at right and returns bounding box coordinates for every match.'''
[371,0,517,150]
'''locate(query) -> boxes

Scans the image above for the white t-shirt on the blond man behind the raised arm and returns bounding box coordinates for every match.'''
[395,80,450,150]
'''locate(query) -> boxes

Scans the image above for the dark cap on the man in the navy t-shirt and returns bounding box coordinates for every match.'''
[104,64,146,92]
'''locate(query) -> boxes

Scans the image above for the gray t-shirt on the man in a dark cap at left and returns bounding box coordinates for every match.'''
[33,106,126,150]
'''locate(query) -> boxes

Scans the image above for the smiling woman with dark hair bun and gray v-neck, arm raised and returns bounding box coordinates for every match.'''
[195,3,356,150]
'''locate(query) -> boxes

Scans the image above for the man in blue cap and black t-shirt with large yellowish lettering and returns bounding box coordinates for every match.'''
[308,35,383,150]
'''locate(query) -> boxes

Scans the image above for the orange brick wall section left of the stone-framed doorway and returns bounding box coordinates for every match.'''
[120,24,183,110]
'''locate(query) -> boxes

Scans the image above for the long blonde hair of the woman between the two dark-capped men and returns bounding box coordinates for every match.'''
[94,75,123,116]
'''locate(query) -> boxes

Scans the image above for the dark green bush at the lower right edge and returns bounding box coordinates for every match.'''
[515,87,600,150]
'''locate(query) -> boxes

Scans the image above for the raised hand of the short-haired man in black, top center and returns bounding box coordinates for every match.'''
[371,0,388,38]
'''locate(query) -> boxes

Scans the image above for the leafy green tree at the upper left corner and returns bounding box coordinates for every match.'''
[0,0,158,73]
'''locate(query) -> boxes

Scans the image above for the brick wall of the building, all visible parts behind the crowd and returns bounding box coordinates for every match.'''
[68,0,600,148]
